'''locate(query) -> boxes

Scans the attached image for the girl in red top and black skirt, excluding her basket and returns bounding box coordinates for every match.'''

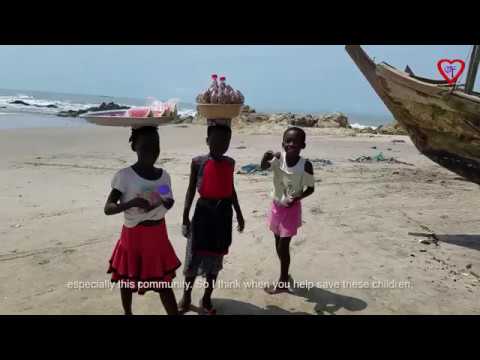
[179,125,245,315]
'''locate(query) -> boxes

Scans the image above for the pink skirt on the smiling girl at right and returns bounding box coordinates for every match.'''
[268,201,302,237]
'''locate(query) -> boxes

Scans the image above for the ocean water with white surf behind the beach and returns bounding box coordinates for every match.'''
[0,89,393,129]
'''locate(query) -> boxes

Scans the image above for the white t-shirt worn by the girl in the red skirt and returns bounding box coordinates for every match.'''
[112,167,173,228]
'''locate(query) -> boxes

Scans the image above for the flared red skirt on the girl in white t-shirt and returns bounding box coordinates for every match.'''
[107,221,181,294]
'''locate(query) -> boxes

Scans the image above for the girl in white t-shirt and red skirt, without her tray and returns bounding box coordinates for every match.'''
[105,127,181,315]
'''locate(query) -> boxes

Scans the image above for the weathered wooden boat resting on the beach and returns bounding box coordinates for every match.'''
[346,45,480,184]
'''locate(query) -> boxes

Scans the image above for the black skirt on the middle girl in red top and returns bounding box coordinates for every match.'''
[192,198,233,256]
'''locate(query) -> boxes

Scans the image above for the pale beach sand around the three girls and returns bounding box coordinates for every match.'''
[0,125,480,315]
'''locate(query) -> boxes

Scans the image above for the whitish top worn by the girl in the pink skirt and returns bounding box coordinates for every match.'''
[270,151,315,205]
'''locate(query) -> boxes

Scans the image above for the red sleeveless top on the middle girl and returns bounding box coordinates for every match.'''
[193,155,235,199]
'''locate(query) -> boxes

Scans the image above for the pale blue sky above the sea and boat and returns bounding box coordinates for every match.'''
[0,45,474,115]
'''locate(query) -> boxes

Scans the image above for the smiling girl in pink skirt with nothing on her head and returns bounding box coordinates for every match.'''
[261,127,315,294]
